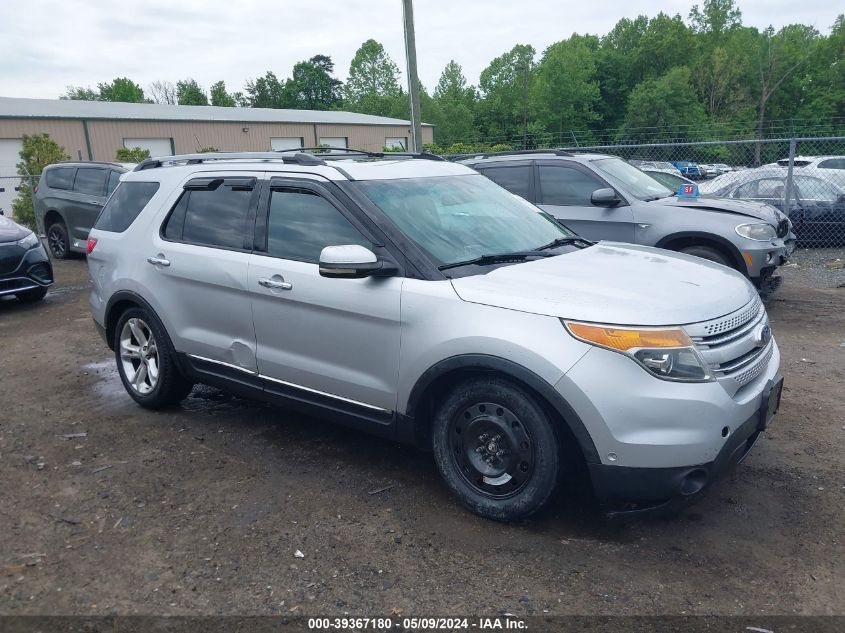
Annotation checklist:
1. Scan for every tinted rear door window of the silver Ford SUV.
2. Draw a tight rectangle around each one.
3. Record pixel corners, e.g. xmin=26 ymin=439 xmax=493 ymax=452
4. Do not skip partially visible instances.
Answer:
xmin=164 ymin=178 xmax=255 ymax=249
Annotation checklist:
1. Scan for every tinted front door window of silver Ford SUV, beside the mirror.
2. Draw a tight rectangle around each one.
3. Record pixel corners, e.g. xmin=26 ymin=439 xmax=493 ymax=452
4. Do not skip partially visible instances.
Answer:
xmin=267 ymin=189 xmax=372 ymax=264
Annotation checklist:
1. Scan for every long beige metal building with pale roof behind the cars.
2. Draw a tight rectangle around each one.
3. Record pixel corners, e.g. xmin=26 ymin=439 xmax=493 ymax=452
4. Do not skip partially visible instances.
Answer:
xmin=0 ymin=97 xmax=433 ymax=168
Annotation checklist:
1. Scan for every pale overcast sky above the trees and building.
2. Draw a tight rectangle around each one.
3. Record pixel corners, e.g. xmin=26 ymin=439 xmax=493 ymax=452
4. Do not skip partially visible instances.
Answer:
xmin=0 ymin=0 xmax=842 ymax=98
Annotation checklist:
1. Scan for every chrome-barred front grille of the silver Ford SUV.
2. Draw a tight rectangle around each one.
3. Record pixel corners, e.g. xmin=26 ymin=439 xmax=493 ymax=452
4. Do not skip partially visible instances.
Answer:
xmin=685 ymin=296 xmax=774 ymax=394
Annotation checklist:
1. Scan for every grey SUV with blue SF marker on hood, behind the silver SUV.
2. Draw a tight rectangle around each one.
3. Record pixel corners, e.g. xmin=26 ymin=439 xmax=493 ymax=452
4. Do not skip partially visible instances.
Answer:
xmin=461 ymin=150 xmax=795 ymax=294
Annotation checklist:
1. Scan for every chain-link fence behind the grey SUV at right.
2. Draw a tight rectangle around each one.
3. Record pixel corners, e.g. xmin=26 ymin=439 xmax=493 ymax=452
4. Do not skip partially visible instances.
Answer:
xmin=562 ymin=136 xmax=845 ymax=248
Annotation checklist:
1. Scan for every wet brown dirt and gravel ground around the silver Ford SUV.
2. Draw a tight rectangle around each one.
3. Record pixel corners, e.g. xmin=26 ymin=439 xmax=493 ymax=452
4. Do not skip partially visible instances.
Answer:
xmin=0 ymin=260 xmax=845 ymax=616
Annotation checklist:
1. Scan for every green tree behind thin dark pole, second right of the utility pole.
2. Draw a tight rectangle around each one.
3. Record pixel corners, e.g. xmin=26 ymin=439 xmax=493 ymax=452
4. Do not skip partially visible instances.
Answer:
xmin=478 ymin=44 xmax=536 ymax=142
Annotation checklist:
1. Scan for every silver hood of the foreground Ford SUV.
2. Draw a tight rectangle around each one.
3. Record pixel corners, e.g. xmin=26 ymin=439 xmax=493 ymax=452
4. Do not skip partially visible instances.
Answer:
xmin=452 ymin=242 xmax=756 ymax=325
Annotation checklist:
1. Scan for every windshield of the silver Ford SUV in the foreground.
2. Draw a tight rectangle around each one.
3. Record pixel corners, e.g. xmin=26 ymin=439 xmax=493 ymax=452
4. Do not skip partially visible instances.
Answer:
xmin=355 ymin=175 xmax=574 ymax=265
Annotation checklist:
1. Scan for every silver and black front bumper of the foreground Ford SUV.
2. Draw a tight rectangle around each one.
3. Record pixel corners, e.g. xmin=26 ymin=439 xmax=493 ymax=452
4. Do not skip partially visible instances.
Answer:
xmin=555 ymin=341 xmax=780 ymax=515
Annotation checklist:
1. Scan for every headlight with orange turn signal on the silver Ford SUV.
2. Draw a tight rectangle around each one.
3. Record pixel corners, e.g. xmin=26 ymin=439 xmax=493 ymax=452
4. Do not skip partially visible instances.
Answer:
xmin=563 ymin=321 xmax=714 ymax=382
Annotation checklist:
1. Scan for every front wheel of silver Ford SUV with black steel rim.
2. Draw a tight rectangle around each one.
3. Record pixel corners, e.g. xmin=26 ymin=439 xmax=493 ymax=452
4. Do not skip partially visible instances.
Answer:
xmin=432 ymin=378 xmax=561 ymax=521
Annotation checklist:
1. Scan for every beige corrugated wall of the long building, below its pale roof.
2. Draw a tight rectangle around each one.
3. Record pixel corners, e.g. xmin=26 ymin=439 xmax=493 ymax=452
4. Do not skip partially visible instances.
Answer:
xmin=0 ymin=119 xmax=433 ymax=160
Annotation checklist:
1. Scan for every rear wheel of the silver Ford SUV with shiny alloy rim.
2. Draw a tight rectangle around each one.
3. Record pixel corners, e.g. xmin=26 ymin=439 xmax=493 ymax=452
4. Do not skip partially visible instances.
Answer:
xmin=114 ymin=308 xmax=192 ymax=409
